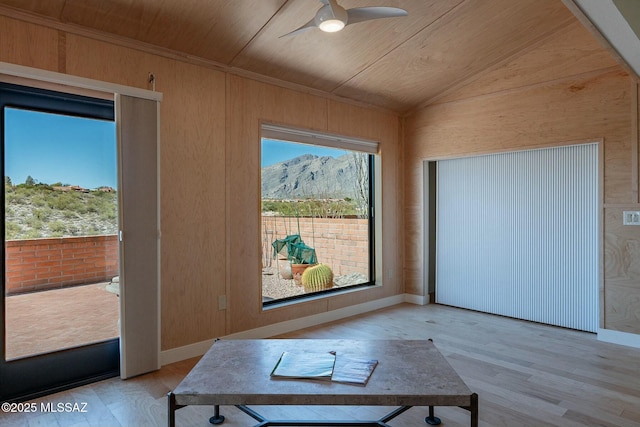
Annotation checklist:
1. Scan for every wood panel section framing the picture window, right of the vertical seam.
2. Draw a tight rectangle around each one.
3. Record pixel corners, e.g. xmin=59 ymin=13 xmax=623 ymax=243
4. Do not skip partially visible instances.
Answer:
xmin=226 ymin=75 xmax=402 ymax=333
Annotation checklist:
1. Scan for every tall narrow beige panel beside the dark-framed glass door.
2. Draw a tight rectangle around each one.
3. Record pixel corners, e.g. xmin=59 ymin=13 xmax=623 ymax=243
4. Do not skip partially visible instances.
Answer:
xmin=116 ymin=95 xmax=160 ymax=379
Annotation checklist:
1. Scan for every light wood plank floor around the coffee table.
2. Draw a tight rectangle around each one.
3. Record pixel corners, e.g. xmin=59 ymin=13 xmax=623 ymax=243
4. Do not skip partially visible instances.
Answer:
xmin=0 ymin=304 xmax=640 ymax=427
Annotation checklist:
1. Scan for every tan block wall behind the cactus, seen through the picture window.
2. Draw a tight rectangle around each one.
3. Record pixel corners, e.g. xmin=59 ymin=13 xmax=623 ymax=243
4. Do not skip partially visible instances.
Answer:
xmin=262 ymin=216 xmax=369 ymax=276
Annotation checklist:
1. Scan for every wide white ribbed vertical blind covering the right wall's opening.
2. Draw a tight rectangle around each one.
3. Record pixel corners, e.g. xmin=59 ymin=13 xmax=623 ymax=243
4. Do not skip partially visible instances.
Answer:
xmin=436 ymin=144 xmax=598 ymax=332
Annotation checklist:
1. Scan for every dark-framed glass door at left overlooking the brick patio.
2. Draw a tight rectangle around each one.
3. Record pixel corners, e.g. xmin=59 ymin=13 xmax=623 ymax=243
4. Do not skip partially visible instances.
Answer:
xmin=0 ymin=84 xmax=120 ymax=401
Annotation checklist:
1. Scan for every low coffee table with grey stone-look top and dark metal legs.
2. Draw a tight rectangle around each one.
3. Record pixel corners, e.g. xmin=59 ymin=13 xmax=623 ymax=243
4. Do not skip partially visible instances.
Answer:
xmin=168 ymin=339 xmax=478 ymax=427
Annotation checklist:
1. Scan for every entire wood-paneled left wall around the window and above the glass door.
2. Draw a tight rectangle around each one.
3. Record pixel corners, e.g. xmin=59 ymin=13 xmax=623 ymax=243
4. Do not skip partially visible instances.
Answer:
xmin=0 ymin=16 xmax=403 ymax=350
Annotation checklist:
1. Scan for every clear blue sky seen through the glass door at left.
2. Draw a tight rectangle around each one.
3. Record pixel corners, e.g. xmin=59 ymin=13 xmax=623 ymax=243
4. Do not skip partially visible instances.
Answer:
xmin=4 ymin=108 xmax=117 ymax=188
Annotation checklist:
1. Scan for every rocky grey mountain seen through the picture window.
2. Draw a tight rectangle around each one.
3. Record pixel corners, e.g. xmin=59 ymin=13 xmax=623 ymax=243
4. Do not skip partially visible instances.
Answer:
xmin=262 ymin=154 xmax=357 ymax=199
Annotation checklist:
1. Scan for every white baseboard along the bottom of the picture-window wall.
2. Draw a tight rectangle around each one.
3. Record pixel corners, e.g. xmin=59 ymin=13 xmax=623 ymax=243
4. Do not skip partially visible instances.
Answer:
xmin=160 ymin=294 xmax=422 ymax=366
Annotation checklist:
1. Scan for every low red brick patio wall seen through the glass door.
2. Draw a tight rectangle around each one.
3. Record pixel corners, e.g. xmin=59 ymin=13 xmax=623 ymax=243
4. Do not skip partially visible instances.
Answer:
xmin=5 ymin=235 xmax=118 ymax=295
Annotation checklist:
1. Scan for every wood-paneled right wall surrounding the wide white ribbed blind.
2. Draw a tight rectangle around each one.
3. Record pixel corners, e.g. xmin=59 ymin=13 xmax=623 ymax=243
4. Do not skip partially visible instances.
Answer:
xmin=404 ymin=21 xmax=640 ymax=334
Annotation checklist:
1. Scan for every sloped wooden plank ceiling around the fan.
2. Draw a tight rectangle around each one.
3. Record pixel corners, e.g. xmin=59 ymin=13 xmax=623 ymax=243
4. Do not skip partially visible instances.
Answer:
xmin=0 ymin=0 xmax=575 ymax=114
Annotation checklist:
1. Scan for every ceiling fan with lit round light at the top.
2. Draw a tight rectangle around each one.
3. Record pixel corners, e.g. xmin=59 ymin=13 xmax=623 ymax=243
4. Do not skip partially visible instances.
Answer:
xmin=280 ymin=0 xmax=408 ymax=37
